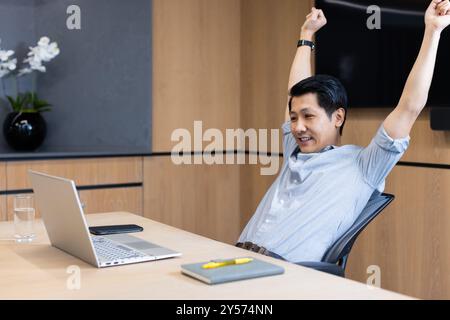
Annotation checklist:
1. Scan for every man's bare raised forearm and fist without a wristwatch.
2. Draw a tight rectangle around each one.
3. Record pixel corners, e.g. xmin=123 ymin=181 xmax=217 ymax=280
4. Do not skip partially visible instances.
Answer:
xmin=383 ymin=0 xmax=450 ymax=139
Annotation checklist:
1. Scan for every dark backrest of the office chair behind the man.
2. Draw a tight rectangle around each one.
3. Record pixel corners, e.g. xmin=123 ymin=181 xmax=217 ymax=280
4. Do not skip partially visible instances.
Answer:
xmin=322 ymin=192 xmax=394 ymax=270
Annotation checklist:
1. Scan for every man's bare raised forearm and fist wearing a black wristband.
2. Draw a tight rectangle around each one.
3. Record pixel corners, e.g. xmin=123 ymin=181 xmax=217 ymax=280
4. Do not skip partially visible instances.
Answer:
xmin=285 ymin=7 xmax=327 ymax=121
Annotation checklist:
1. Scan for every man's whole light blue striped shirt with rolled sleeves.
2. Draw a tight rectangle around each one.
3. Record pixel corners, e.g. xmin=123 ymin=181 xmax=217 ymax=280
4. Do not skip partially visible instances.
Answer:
xmin=239 ymin=121 xmax=410 ymax=262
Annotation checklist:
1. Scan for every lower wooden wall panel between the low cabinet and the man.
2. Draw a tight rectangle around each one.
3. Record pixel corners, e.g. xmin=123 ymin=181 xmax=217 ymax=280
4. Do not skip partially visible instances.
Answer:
xmin=144 ymin=157 xmax=240 ymax=244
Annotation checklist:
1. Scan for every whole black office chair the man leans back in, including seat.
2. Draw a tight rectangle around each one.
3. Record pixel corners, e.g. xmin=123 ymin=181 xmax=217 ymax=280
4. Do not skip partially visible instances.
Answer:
xmin=296 ymin=192 xmax=394 ymax=277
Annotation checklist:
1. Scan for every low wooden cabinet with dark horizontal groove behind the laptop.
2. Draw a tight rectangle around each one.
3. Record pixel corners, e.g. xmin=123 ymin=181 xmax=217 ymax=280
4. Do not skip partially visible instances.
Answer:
xmin=0 ymin=157 xmax=143 ymax=220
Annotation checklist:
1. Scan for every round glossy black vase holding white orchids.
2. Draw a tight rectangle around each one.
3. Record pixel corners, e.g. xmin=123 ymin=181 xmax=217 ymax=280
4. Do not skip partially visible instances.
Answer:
xmin=3 ymin=112 xmax=47 ymax=151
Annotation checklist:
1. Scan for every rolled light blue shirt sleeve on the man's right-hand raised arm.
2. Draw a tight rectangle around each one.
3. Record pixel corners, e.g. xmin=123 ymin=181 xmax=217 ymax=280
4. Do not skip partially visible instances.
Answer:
xmin=358 ymin=125 xmax=410 ymax=192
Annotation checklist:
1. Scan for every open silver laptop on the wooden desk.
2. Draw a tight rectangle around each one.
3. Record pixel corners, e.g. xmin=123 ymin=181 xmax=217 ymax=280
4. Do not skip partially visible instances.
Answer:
xmin=28 ymin=170 xmax=181 ymax=268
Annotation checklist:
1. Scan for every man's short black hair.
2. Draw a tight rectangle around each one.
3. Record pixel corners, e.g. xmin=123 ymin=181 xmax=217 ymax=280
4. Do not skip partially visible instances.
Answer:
xmin=289 ymin=74 xmax=347 ymax=135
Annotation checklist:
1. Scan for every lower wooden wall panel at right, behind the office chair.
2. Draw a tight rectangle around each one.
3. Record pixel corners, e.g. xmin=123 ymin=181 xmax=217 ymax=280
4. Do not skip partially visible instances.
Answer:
xmin=347 ymin=166 xmax=450 ymax=299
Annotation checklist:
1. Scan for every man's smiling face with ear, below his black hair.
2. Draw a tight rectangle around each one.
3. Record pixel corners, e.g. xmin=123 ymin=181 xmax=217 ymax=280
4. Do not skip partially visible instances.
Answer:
xmin=290 ymin=93 xmax=345 ymax=153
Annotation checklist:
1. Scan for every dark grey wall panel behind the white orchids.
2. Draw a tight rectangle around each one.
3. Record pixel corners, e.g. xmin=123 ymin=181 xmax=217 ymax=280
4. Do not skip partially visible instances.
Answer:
xmin=0 ymin=0 xmax=151 ymax=150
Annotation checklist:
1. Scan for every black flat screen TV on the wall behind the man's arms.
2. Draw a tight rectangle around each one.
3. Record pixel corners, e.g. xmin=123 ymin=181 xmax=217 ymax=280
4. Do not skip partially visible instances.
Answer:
xmin=316 ymin=0 xmax=450 ymax=109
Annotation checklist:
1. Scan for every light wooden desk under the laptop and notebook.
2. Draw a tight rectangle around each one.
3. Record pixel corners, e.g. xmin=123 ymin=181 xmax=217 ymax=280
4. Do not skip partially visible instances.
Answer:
xmin=0 ymin=212 xmax=414 ymax=299
